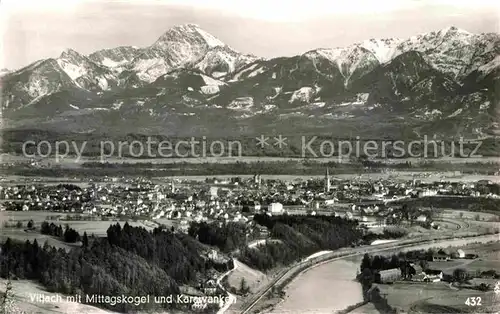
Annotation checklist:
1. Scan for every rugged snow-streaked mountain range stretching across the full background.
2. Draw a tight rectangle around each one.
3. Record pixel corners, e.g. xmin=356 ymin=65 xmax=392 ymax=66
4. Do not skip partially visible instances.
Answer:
xmin=0 ymin=24 xmax=500 ymax=138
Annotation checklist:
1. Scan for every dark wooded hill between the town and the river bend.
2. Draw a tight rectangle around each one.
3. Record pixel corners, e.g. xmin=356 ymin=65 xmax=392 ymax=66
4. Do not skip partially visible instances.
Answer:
xmin=188 ymin=214 xmax=376 ymax=271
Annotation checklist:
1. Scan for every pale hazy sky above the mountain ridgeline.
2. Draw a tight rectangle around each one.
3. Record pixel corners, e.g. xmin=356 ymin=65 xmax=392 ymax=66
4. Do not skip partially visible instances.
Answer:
xmin=0 ymin=0 xmax=500 ymax=69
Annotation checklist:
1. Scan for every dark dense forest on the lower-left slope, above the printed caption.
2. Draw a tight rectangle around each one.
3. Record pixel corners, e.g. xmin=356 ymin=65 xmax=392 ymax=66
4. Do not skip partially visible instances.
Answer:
xmin=0 ymin=224 xmax=233 ymax=313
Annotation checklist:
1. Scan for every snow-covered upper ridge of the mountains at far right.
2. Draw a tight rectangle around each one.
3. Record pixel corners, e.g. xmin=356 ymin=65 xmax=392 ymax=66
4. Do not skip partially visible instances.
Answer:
xmin=305 ymin=26 xmax=492 ymax=78
